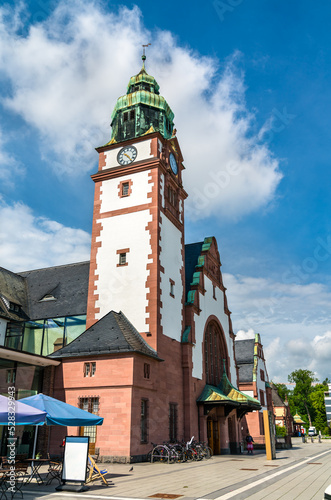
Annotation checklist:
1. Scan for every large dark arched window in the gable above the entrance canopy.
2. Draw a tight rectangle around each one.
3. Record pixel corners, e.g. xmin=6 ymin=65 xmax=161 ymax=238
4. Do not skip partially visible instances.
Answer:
xmin=204 ymin=321 xmax=228 ymax=386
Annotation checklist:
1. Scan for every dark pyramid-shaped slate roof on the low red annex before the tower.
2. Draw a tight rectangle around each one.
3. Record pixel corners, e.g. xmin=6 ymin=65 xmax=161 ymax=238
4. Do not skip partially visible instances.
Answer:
xmin=50 ymin=311 xmax=160 ymax=360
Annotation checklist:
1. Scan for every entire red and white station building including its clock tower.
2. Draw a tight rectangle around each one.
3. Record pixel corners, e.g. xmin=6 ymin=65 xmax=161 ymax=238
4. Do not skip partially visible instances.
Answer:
xmin=0 ymin=56 xmax=261 ymax=462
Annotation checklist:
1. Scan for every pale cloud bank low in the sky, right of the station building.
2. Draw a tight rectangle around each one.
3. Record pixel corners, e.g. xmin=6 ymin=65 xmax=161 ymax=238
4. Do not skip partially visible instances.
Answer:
xmin=227 ymin=274 xmax=331 ymax=382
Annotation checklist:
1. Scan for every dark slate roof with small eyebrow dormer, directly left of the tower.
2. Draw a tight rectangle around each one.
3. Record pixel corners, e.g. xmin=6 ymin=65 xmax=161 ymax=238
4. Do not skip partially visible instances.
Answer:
xmin=17 ymin=262 xmax=90 ymax=320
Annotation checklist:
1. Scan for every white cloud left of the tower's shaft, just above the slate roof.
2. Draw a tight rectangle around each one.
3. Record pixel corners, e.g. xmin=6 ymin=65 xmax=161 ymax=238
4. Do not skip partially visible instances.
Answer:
xmin=0 ymin=203 xmax=91 ymax=272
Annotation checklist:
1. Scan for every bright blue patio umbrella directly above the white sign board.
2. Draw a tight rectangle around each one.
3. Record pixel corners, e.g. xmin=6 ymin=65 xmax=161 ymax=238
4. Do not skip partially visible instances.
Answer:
xmin=20 ymin=394 xmax=103 ymax=427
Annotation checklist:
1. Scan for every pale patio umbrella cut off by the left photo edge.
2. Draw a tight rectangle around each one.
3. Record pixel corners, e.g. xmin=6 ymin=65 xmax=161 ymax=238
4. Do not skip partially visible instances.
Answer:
xmin=0 ymin=395 xmax=46 ymax=425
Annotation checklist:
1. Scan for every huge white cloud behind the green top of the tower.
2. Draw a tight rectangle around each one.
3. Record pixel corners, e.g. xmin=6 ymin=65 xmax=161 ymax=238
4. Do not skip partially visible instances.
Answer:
xmin=0 ymin=1 xmax=281 ymax=218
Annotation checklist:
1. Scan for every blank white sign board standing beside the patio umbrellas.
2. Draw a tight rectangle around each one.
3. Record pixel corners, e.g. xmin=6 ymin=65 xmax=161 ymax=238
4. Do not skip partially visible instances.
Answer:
xmin=62 ymin=436 xmax=89 ymax=483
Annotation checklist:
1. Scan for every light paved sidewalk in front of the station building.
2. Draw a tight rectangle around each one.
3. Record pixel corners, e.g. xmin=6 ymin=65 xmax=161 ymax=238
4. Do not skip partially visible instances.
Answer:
xmin=19 ymin=438 xmax=331 ymax=500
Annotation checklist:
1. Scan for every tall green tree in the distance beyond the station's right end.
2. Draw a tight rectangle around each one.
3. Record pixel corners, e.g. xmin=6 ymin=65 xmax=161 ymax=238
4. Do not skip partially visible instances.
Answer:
xmin=288 ymin=369 xmax=317 ymax=426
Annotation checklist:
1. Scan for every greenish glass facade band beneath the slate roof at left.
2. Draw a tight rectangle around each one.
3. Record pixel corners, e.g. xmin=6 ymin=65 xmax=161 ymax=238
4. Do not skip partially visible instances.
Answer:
xmin=5 ymin=315 xmax=86 ymax=356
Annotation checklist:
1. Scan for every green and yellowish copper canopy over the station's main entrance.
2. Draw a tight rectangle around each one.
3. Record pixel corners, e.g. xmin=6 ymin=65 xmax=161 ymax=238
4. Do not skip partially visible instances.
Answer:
xmin=197 ymin=369 xmax=262 ymax=418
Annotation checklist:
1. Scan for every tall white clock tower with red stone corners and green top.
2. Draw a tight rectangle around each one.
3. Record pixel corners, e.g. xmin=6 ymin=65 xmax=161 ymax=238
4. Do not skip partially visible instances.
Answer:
xmin=87 ymin=56 xmax=187 ymax=351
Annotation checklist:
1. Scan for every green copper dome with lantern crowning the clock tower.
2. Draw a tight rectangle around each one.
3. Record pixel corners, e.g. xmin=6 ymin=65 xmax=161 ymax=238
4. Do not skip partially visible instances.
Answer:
xmin=110 ymin=59 xmax=174 ymax=144
